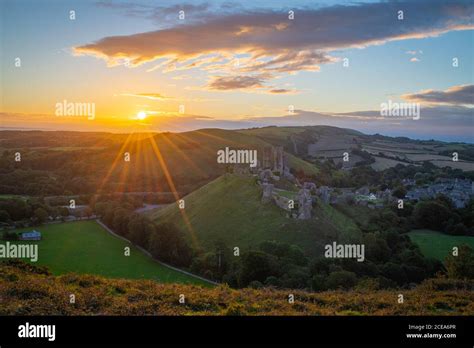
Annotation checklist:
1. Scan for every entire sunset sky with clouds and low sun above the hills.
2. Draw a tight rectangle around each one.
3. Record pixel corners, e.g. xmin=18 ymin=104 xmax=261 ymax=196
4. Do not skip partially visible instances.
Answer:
xmin=0 ymin=0 xmax=474 ymax=142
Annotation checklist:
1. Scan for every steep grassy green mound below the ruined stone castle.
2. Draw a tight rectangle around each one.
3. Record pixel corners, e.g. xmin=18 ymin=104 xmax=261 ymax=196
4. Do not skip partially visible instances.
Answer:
xmin=148 ymin=174 xmax=360 ymax=255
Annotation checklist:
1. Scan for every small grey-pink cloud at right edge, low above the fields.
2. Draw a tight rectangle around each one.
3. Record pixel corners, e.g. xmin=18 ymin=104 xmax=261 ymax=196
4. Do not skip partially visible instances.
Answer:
xmin=402 ymin=85 xmax=474 ymax=105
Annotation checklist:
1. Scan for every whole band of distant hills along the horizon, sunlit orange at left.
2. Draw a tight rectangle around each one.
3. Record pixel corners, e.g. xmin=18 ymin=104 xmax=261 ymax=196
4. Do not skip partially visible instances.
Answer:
xmin=0 ymin=126 xmax=474 ymax=196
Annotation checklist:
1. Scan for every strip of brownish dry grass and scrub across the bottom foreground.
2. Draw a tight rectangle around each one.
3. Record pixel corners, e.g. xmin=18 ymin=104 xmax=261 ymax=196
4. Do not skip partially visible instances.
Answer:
xmin=0 ymin=262 xmax=474 ymax=315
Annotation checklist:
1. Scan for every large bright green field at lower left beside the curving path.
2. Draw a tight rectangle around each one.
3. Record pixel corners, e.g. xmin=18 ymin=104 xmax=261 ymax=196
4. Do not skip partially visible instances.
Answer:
xmin=5 ymin=221 xmax=209 ymax=285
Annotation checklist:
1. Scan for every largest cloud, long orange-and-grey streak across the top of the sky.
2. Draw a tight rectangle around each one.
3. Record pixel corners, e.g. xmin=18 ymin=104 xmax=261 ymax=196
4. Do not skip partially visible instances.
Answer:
xmin=74 ymin=0 xmax=474 ymax=89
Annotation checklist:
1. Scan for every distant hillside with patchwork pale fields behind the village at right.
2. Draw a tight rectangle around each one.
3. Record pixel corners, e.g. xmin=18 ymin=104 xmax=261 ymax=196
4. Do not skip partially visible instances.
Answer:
xmin=243 ymin=126 xmax=474 ymax=172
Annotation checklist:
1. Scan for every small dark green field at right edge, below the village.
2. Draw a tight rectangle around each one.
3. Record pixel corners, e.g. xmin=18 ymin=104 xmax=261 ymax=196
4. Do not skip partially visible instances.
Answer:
xmin=408 ymin=230 xmax=474 ymax=261
